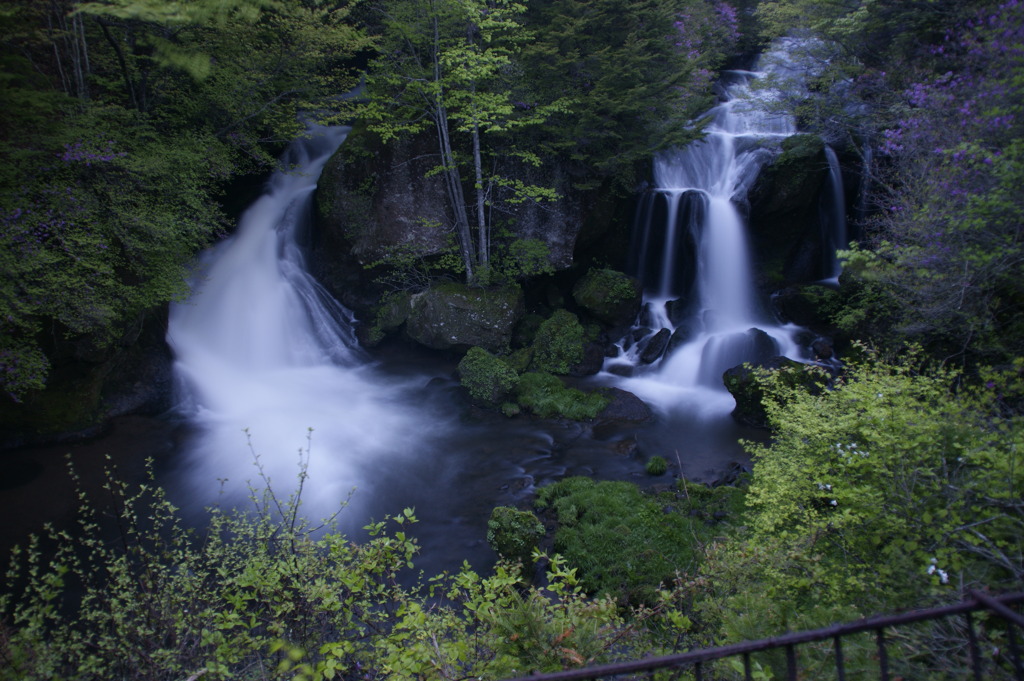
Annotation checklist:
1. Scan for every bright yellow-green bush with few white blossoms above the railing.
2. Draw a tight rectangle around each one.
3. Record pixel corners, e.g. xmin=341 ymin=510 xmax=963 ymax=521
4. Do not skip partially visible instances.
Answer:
xmin=707 ymin=353 xmax=1024 ymax=640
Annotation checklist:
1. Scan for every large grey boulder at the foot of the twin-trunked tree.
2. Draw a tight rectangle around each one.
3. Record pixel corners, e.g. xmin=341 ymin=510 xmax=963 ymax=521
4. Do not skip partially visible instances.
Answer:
xmin=406 ymin=283 xmax=526 ymax=353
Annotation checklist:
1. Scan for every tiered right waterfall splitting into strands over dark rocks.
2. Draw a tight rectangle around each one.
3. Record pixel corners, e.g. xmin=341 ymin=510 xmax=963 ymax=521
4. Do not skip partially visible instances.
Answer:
xmin=605 ymin=41 xmax=819 ymax=412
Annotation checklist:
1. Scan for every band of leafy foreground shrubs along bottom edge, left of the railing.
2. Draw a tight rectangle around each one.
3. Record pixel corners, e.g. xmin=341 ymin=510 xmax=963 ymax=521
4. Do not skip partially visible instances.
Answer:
xmin=0 ymin=458 xmax=682 ymax=681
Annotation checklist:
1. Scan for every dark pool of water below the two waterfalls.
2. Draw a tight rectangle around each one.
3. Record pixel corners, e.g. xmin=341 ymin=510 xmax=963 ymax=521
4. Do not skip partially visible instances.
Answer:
xmin=0 ymin=343 xmax=760 ymax=574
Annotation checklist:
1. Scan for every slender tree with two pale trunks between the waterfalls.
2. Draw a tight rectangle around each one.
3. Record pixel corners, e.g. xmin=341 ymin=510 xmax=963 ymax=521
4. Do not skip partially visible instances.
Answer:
xmin=362 ymin=0 xmax=563 ymax=282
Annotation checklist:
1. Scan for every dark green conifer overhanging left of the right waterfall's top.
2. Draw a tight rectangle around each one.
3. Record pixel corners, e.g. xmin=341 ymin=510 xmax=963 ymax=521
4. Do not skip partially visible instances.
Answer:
xmin=520 ymin=0 xmax=738 ymax=191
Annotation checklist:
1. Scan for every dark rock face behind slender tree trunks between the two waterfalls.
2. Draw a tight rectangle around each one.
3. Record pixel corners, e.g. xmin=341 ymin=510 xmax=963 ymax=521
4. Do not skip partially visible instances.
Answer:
xmin=314 ymin=127 xmax=585 ymax=296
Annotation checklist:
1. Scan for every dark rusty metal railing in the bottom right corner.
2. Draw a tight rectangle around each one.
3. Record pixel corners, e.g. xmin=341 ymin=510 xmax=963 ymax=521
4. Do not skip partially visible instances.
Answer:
xmin=501 ymin=591 xmax=1024 ymax=681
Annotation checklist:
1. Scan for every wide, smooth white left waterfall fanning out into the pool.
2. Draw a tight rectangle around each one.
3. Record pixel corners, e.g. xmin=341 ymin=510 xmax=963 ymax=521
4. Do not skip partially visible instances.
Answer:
xmin=167 ymin=126 xmax=431 ymax=515
